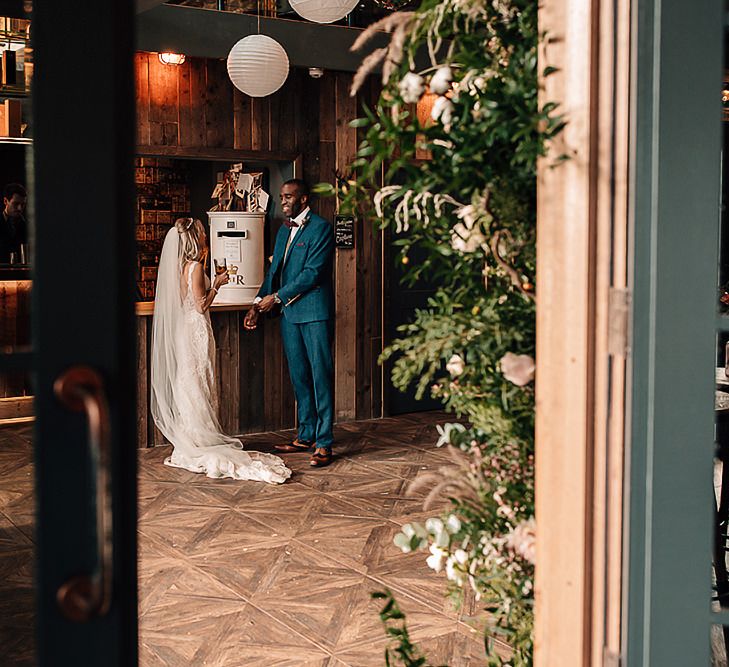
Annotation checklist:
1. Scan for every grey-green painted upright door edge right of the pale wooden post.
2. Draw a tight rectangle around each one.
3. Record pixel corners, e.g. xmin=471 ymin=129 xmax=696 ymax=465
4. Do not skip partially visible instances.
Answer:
xmin=624 ymin=0 xmax=725 ymax=667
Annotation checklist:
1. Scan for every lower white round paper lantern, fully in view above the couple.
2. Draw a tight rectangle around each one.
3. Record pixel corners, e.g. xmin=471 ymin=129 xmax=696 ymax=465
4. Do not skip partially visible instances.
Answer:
xmin=228 ymin=35 xmax=289 ymax=97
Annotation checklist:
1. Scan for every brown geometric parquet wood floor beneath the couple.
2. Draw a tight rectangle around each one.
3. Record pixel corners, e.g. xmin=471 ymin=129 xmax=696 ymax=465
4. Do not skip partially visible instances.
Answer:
xmin=0 ymin=413 xmax=506 ymax=667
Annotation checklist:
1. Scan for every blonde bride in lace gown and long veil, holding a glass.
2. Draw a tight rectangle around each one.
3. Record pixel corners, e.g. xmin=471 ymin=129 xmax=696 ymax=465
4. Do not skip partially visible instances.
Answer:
xmin=151 ymin=218 xmax=291 ymax=484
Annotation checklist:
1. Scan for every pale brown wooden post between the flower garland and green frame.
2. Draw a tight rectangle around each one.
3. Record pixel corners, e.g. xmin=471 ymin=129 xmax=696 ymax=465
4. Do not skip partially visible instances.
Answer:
xmin=535 ymin=0 xmax=630 ymax=667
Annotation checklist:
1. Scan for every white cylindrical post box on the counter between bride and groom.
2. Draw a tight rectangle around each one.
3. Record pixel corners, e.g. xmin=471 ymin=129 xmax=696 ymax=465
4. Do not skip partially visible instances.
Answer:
xmin=208 ymin=211 xmax=266 ymax=306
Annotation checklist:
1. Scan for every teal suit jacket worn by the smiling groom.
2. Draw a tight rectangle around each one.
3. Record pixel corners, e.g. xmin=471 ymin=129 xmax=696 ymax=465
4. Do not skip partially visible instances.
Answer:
xmin=258 ymin=213 xmax=334 ymax=324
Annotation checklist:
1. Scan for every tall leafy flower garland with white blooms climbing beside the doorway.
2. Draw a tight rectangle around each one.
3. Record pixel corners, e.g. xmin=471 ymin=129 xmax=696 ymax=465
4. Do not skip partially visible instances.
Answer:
xmin=316 ymin=0 xmax=562 ymax=666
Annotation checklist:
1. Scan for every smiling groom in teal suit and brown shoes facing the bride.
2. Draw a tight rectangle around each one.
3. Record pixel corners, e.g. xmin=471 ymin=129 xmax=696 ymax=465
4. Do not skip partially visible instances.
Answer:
xmin=243 ymin=178 xmax=334 ymax=467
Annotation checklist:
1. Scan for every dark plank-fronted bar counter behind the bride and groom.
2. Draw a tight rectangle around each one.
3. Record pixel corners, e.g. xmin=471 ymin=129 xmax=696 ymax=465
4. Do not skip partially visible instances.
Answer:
xmin=137 ymin=302 xmax=296 ymax=447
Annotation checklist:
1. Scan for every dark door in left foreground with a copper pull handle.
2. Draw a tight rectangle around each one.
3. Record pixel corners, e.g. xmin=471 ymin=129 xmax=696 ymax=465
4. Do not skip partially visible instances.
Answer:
xmin=25 ymin=0 xmax=137 ymax=667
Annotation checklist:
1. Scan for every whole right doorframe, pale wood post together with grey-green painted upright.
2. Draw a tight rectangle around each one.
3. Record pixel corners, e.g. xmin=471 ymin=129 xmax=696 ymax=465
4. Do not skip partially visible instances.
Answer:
xmin=535 ymin=0 xmax=725 ymax=667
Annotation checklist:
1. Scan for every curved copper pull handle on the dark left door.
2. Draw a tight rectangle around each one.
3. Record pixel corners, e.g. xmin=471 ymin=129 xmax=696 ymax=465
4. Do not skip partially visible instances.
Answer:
xmin=53 ymin=366 xmax=114 ymax=622
